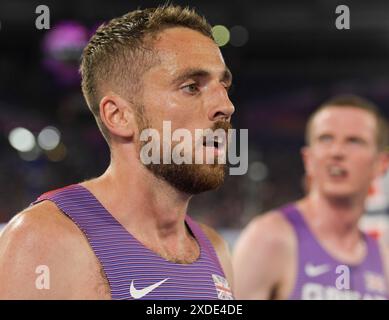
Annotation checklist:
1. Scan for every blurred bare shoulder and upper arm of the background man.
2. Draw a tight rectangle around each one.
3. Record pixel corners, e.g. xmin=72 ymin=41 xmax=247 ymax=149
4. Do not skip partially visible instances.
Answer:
xmin=233 ymin=212 xmax=294 ymax=300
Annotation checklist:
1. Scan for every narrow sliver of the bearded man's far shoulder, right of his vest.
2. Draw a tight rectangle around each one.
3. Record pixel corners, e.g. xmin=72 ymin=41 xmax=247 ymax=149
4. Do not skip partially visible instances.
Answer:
xmin=199 ymin=223 xmax=233 ymax=286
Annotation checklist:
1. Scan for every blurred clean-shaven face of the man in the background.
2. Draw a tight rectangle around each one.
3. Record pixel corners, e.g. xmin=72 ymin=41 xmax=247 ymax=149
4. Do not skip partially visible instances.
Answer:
xmin=303 ymin=106 xmax=386 ymax=198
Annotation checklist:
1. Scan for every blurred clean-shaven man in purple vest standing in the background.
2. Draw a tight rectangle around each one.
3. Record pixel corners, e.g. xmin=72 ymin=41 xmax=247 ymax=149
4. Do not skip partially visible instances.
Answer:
xmin=233 ymin=96 xmax=389 ymax=300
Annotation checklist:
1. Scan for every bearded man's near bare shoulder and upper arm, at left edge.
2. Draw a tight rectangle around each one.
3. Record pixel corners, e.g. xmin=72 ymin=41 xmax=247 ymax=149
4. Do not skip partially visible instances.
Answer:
xmin=0 ymin=201 xmax=104 ymax=299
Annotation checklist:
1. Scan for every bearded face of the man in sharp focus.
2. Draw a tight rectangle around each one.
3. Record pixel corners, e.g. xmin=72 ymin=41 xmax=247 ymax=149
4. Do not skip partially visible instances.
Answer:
xmin=135 ymin=28 xmax=234 ymax=194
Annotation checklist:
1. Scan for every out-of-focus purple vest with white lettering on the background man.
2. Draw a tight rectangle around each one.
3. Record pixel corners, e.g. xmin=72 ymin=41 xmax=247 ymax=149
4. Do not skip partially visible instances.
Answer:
xmin=281 ymin=205 xmax=388 ymax=300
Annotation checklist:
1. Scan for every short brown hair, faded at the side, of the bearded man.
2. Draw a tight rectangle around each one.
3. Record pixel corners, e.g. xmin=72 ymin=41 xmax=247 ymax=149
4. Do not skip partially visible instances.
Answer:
xmin=80 ymin=5 xmax=213 ymax=144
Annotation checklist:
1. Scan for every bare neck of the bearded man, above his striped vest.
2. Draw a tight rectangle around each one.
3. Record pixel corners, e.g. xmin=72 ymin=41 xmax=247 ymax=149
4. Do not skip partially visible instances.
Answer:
xmin=84 ymin=154 xmax=190 ymax=240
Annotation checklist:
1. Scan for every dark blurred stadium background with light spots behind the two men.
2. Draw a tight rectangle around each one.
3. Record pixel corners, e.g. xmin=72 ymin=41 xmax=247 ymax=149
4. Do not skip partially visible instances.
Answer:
xmin=0 ymin=0 xmax=389 ymax=238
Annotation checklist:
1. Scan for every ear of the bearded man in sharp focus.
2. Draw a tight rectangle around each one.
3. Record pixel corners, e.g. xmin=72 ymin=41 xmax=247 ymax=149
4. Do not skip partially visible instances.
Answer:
xmin=99 ymin=94 xmax=136 ymax=138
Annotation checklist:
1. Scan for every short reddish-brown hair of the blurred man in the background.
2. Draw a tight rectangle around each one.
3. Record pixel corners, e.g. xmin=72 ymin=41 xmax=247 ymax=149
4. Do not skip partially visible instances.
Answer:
xmin=305 ymin=95 xmax=389 ymax=151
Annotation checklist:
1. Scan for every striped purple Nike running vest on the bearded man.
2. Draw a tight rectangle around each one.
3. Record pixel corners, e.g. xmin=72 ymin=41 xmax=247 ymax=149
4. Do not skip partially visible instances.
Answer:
xmin=33 ymin=184 xmax=233 ymax=300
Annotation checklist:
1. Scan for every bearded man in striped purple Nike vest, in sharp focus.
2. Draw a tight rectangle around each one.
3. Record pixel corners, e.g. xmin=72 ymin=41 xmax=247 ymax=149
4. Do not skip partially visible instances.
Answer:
xmin=0 ymin=6 xmax=234 ymax=299
